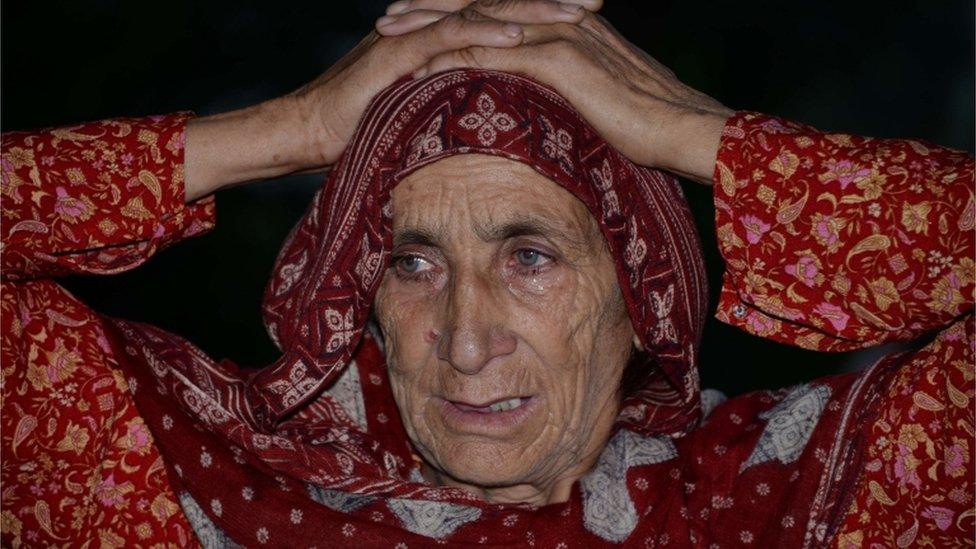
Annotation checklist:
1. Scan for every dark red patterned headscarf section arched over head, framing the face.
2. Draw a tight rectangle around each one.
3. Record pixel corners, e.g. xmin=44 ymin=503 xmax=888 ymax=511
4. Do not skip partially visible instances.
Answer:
xmin=255 ymin=70 xmax=707 ymax=434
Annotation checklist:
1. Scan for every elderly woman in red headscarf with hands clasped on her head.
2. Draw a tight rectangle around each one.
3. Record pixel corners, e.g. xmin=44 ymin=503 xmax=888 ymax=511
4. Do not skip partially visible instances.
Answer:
xmin=2 ymin=0 xmax=976 ymax=547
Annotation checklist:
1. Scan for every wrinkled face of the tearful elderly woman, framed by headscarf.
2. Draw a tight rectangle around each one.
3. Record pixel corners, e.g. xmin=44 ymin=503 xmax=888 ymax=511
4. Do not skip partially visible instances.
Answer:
xmin=376 ymin=154 xmax=634 ymax=503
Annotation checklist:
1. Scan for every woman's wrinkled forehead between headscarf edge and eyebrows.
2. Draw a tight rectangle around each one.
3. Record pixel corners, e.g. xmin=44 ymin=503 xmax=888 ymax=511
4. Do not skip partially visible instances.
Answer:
xmin=391 ymin=150 xmax=606 ymax=253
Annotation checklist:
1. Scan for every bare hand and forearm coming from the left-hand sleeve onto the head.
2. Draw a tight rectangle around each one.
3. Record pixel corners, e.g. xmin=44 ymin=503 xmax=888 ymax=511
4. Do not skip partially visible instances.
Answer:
xmin=185 ymin=0 xmax=599 ymax=201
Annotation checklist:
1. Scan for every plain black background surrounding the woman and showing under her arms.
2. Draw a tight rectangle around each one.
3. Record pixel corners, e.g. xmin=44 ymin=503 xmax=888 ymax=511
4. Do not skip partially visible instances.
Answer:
xmin=0 ymin=0 xmax=974 ymax=394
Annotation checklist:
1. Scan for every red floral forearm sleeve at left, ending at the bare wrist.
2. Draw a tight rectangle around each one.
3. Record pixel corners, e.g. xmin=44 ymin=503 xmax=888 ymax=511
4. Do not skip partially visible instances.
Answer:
xmin=0 ymin=114 xmax=214 ymax=280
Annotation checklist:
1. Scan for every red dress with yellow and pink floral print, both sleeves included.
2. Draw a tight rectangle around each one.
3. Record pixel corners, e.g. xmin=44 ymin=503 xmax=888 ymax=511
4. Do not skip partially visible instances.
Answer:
xmin=0 ymin=113 xmax=976 ymax=547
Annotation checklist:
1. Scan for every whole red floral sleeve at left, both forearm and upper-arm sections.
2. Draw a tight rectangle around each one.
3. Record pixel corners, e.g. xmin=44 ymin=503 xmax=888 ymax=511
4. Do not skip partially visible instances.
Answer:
xmin=0 ymin=115 xmax=213 ymax=547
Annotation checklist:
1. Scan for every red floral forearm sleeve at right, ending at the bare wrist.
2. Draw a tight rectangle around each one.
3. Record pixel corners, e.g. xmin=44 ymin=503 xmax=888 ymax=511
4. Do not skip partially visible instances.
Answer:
xmin=714 ymin=112 xmax=976 ymax=351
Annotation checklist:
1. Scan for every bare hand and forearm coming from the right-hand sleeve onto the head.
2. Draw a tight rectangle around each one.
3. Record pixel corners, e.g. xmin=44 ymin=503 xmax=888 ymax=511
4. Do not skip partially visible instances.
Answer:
xmin=378 ymin=0 xmax=733 ymax=184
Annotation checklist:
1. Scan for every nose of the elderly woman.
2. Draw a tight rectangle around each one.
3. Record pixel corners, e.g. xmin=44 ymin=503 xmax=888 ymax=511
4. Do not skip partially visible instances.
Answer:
xmin=436 ymin=273 xmax=517 ymax=375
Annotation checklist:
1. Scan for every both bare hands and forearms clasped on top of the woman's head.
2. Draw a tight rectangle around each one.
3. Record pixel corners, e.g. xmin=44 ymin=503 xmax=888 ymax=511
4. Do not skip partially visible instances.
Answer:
xmin=185 ymin=0 xmax=732 ymax=200
